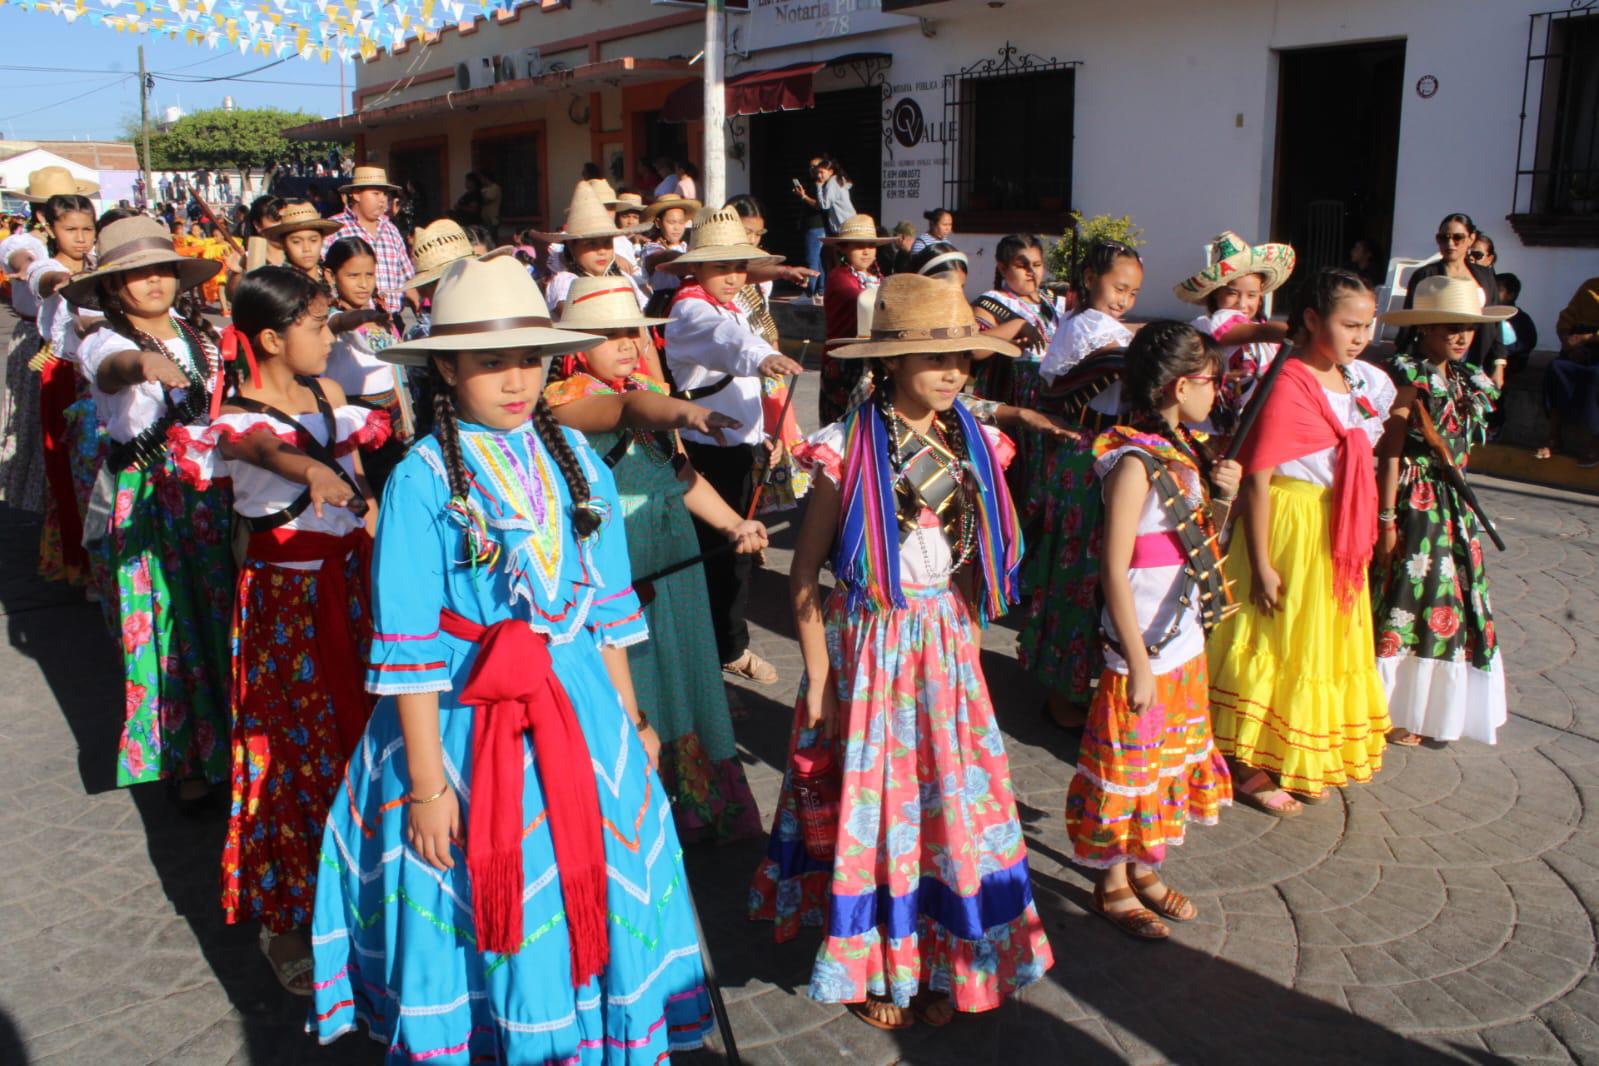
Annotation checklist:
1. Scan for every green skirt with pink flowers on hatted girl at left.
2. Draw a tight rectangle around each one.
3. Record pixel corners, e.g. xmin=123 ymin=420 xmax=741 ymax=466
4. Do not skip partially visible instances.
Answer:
xmin=109 ymin=452 xmax=233 ymax=785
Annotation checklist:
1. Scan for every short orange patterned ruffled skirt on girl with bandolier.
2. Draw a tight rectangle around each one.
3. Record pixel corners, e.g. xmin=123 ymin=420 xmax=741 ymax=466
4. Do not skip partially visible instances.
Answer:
xmin=1067 ymin=655 xmax=1233 ymax=869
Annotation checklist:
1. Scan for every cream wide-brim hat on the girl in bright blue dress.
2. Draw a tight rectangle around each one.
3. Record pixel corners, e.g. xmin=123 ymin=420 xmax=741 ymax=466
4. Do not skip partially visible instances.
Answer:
xmin=377 ymin=256 xmax=604 ymax=366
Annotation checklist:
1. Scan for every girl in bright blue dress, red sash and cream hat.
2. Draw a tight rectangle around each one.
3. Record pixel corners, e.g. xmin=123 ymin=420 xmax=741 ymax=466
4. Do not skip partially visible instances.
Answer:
xmin=309 ymin=257 xmax=712 ymax=1066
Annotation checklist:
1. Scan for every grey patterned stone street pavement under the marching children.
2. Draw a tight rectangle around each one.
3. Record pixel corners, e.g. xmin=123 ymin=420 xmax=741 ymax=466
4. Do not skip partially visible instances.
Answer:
xmin=0 ymin=362 xmax=1599 ymax=1066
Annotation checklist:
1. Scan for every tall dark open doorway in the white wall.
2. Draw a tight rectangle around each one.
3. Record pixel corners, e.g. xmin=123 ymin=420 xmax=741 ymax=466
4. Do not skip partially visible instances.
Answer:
xmin=1271 ymin=40 xmax=1404 ymax=295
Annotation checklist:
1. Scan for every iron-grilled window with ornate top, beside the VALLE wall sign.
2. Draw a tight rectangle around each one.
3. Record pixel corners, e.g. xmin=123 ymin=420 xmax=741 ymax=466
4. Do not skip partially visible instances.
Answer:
xmin=943 ymin=43 xmax=1078 ymax=232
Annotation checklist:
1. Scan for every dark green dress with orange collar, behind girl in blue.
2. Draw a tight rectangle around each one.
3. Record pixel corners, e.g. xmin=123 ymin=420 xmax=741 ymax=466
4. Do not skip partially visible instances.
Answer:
xmin=545 ymin=371 xmax=761 ymax=842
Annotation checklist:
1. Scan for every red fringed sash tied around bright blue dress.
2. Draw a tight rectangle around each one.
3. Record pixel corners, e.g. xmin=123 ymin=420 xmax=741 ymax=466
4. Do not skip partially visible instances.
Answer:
xmin=438 ymin=611 xmax=611 ymax=988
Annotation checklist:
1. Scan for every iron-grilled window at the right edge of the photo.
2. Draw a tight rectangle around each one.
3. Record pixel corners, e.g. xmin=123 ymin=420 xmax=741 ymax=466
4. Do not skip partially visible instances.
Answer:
xmin=1509 ymin=0 xmax=1599 ymax=245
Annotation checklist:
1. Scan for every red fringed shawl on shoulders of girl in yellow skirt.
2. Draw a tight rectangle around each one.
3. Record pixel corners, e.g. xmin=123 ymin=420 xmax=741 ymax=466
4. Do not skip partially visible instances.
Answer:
xmin=1238 ymin=358 xmax=1377 ymax=614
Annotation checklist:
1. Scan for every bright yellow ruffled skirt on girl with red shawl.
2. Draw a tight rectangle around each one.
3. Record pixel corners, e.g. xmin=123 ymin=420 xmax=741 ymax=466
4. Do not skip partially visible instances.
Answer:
xmin=1206 ymin=478 xmax=1388 ymax=794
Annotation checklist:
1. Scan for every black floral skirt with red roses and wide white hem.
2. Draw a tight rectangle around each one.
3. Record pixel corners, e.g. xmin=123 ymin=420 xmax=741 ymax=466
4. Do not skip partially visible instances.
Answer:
xmin=1372 ymin=457 xmax=1509 ymax=745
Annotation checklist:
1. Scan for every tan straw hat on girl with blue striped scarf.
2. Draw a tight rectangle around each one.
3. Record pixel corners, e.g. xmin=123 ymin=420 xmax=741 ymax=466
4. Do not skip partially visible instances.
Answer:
xmin=828 ymin=273 xmax=1022 ymax=360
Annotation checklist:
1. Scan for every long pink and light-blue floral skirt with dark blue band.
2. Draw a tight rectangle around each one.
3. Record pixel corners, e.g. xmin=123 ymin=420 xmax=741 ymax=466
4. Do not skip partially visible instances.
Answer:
xmin=750 ymin=587 xmax=1054 ymax=1012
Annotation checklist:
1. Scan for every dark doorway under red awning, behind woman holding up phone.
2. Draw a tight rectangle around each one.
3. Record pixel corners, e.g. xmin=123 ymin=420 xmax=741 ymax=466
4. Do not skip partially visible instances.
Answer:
xmin=748 ymin=88 xmax=892 ymax=265
